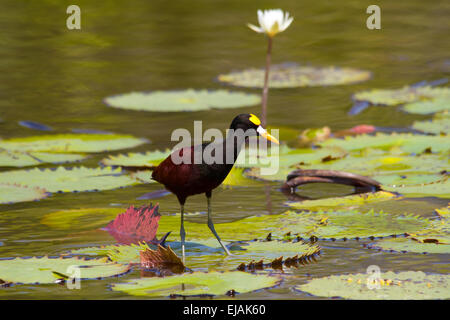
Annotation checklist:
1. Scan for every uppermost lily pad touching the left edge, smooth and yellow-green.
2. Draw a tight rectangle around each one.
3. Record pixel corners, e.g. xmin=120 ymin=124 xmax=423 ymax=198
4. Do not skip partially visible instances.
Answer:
xmin=0 ymin=133 xmax=148 ymax=153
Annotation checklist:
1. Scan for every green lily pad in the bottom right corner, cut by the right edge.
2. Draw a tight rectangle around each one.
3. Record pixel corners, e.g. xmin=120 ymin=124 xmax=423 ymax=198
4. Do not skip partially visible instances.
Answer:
xmin=295 ymin=271 xmax=450 ymax=300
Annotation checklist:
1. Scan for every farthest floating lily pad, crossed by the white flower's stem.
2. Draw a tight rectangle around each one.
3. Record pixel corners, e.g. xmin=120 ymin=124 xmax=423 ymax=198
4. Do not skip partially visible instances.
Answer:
xmin=218 ymin=63 xmax=371 ymax=88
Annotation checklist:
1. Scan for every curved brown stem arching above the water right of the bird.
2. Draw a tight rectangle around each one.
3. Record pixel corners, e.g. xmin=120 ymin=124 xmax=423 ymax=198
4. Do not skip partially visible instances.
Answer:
xmin=281 ymin=170 xmax=381 ymax=193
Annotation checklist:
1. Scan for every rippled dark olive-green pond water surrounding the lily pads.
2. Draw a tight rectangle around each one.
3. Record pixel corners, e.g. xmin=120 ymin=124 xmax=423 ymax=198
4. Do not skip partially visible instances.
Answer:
xmin=0 ymin=0 xmax=450 ymax=299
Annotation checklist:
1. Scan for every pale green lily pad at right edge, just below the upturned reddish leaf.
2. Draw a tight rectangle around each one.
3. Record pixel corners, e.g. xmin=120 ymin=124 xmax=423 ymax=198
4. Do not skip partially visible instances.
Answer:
xmin=321 ymin=133 xmax=450 ymax=153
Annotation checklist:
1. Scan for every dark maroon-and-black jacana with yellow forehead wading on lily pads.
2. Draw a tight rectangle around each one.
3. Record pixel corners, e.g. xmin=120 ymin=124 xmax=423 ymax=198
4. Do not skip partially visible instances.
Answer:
xmin=152 ymin=114 xmax=279 ymax=260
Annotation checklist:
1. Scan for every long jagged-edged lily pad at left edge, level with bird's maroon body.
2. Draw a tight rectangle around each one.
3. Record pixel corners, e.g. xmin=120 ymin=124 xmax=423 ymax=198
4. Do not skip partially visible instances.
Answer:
xmin=0 ymin=167 xmax=137 ymax=192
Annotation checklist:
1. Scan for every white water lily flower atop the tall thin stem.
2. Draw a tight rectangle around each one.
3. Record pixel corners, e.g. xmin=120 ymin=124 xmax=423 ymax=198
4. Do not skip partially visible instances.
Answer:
xmin=247 ymin=9 xmax=294 ymax=37
